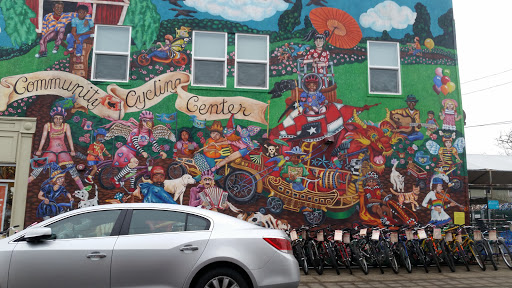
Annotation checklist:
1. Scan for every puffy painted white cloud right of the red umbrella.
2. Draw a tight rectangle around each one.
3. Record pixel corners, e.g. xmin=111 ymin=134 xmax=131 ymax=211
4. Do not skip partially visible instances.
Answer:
xmin=360 ymin=0 xmax=416 ymax=32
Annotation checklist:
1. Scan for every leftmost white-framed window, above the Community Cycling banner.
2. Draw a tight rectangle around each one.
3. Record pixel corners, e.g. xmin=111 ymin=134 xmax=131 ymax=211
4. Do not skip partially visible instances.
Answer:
xmin=91 ymin=25 xmax=132 ymax=82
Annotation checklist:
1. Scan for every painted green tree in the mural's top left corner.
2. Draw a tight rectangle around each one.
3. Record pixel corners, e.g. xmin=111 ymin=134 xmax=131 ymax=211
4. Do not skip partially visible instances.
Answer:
xmin=0 ymin=1 xmax=37 ymax=48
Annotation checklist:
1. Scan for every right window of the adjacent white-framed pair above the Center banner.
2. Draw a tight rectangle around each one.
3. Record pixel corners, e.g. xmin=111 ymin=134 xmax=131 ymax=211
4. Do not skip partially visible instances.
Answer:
xmin=235 ymin=33 xmax=269 ymax=89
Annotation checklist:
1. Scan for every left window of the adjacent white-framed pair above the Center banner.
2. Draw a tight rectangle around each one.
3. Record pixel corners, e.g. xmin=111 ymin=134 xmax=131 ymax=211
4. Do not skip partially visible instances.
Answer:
xmin=192 ymin=31 xmax=228 ymax=87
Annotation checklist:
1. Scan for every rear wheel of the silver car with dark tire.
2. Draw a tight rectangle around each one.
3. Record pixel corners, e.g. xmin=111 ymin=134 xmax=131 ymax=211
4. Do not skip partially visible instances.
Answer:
xmin=194 ymin=268 xmax=249 ymax=288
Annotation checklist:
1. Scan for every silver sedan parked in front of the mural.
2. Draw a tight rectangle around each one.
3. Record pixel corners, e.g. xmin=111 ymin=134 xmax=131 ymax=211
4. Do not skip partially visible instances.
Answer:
xmin=0 ymin=204 xmax=300 ymax=288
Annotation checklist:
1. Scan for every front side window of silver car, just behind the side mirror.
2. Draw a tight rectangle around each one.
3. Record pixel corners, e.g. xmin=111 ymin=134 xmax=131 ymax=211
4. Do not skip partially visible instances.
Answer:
xmin=46 ymin=210 xmax=121 ymax=239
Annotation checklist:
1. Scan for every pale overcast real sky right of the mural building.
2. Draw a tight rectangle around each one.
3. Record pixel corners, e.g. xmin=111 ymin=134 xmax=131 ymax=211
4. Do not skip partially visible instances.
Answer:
xmin=452 ymin=0 xmax=512 ymax=155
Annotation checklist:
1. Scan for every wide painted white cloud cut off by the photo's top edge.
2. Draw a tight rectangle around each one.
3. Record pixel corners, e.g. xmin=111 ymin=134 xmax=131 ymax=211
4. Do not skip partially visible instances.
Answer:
xmin=184 ymin=0 xmax=288 ymax=21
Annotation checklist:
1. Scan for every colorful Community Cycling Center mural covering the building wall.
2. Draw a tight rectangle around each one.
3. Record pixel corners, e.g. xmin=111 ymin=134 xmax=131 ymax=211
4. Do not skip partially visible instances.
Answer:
xmin=0 ymin=0 xmax=468 ymax=229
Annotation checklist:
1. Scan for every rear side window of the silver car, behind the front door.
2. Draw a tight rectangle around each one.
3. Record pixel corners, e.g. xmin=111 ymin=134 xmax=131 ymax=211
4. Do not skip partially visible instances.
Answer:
xmin=128 ymin=210 xmax=210 ymax=234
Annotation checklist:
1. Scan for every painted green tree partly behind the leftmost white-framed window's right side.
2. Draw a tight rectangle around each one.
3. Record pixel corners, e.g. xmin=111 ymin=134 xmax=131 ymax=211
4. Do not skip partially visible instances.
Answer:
xmin=124 ymin=0 xmax=160 ymax=49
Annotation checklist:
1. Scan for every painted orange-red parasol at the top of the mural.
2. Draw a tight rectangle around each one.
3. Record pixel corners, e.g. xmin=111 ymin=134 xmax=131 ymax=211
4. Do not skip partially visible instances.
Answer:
xmin=309 ymin=7 xmax=363 ymax=48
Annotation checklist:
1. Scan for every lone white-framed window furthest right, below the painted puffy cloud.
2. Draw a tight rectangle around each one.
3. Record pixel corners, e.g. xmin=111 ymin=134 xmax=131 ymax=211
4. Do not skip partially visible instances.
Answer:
xmin=367 ymin=41 xmax=402 ymax=95
